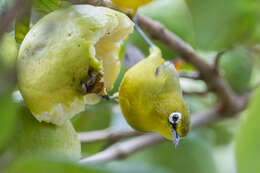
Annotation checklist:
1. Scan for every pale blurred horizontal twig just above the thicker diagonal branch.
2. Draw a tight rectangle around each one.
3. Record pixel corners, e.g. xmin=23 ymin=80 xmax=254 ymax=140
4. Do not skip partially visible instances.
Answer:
xmin=78 ymin=129 xmax=143 ymax=143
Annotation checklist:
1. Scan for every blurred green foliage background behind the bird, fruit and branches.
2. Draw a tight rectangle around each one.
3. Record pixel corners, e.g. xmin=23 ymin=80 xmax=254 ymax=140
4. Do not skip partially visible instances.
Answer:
xmin=0 ymin=0 xmax=260 ymax=173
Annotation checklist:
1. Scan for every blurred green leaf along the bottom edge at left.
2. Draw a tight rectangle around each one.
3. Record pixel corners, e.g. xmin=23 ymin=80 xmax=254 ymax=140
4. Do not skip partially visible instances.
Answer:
xmin=4 ymin=154 xmax=108 ymax=173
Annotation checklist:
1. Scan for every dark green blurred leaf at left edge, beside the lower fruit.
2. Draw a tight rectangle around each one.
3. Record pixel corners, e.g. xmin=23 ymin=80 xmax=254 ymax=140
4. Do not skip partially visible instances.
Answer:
xmin=0 ymin=92 xmax=17 ymax=150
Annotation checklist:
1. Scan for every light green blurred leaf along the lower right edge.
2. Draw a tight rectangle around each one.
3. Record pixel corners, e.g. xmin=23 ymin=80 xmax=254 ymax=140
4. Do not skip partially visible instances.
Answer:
xmin=236 ymin=88 xmax=260 ymax=173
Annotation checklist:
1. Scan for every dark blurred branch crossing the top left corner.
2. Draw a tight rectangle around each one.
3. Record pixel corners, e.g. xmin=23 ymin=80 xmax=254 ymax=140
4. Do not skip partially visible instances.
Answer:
xmin=0 ymin=0 xmax=31 ymax=38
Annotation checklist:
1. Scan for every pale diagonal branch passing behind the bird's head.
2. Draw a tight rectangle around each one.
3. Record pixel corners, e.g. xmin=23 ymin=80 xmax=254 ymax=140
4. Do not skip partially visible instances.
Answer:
xmin=80 ymin=106 xmax=220 ymax=164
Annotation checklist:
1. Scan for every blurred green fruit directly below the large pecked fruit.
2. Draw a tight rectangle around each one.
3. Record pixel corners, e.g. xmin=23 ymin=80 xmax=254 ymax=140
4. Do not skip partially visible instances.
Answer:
xmin=15 ymin=107 xmax=81 ymax=160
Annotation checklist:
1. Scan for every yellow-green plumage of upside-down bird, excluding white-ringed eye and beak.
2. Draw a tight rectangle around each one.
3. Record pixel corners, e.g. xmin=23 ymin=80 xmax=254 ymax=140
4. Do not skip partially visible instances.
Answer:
xmin=119 ymin=47 xmax=190 ymax=140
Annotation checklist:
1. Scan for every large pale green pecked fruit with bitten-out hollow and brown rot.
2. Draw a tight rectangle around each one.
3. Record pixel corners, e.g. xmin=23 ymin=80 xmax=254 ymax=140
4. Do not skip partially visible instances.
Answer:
xmin=17 ymin=5 xmax=134 ymax=125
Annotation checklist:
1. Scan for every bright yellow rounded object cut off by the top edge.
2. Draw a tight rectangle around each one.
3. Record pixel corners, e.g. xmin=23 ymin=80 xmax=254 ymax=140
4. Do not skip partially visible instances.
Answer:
xmin=112 ymin=0 xmax=153 ymax=10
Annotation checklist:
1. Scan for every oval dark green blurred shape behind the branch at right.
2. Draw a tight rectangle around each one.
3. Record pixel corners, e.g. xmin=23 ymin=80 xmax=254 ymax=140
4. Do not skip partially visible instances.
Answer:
xmin=220 ymin=46 xmax=253 ymax=93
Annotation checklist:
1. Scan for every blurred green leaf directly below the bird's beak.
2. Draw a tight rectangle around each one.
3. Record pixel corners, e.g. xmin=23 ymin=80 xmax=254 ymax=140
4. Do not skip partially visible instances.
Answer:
xmin=132 ymin=132 xmax=217 ymax=173
